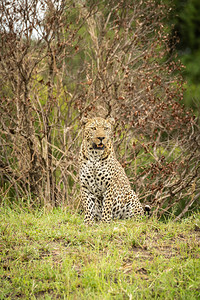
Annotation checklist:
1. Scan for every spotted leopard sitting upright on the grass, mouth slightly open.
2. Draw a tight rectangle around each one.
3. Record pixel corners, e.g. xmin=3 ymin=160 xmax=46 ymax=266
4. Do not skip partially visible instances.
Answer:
xmin=79 ymin=117 xmax=148 ymax=225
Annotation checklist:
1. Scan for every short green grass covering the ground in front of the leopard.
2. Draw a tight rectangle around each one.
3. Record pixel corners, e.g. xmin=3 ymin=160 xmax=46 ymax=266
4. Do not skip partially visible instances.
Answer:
xmin=0 ymin=209 xmax=200 ymax=300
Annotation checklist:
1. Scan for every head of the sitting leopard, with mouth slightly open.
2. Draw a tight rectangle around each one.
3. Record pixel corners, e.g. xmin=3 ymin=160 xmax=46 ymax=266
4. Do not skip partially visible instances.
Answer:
xmin=82 ymin=117 xmax=115 ymax=151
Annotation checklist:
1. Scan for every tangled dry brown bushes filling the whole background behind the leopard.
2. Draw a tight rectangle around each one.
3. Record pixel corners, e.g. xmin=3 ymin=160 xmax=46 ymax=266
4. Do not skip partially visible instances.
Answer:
xmin=0 ymin=0 xmax=200 ymax=219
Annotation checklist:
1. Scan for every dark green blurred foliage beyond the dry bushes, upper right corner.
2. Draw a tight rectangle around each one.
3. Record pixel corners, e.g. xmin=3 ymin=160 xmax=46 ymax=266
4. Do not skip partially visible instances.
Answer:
xmin=171 ymin=0 xmax=200 ymax=113
